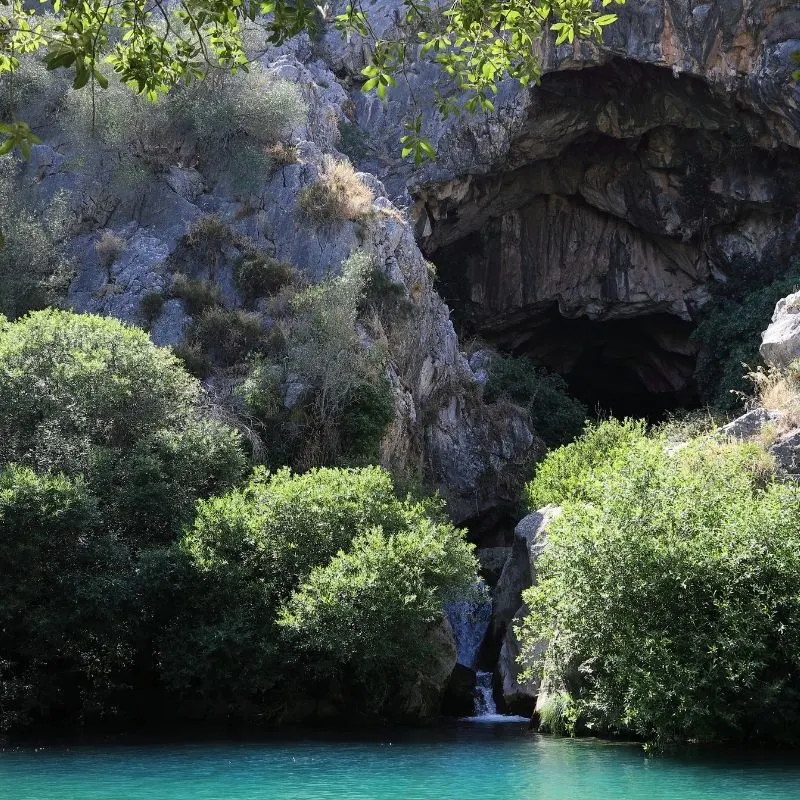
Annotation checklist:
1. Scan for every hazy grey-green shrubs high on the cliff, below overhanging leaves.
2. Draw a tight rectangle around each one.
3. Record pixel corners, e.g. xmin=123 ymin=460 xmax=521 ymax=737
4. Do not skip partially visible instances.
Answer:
xmin=59 ymin=63 xmax=306 ymax=196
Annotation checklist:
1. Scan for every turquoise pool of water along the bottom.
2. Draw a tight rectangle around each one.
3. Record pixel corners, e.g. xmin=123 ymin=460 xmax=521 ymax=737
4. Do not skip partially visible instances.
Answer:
xmin=0 ymin=724 xmax=800 ymax=800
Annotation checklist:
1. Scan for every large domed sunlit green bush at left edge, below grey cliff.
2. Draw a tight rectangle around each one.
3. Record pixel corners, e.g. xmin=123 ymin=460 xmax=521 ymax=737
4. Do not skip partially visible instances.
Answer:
xmin=0 ymin=311 xmax=244 ymax=541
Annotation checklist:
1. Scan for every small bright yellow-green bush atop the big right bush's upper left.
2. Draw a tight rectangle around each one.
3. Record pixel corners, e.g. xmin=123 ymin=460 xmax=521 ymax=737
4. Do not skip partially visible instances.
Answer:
xmin=525 ymin=419 xmax=645 ymax=510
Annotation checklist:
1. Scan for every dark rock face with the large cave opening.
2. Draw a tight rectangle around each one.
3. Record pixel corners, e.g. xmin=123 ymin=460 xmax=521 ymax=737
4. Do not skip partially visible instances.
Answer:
xmin=326 ymin=0 xmax=800 ymax=412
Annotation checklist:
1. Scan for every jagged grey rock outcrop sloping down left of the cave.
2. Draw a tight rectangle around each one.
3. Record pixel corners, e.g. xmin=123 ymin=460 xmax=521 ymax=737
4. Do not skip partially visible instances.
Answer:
xmin=14 ymin=37 xmax=542 ymax=522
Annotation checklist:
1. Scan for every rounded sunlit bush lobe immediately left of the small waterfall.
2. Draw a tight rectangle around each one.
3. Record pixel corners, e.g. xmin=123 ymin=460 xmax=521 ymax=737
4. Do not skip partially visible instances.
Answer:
xmin=280 ymin=514 xmax=475 ymax=687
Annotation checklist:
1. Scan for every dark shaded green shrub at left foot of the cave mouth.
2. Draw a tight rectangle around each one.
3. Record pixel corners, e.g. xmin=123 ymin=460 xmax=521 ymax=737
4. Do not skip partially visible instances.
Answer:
xmin=484 ymin=355 xmax=586 ymax=447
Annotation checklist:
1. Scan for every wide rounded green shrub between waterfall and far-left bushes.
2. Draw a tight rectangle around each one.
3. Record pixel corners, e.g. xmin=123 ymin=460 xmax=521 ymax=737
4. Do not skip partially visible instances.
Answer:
xmin=159 ymin=467 xmax=475 ymax=717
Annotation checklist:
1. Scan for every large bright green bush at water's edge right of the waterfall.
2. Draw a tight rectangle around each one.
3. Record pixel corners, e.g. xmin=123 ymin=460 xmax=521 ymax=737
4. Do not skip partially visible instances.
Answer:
xmin=521 ymin=422 xmax=800 ymax=746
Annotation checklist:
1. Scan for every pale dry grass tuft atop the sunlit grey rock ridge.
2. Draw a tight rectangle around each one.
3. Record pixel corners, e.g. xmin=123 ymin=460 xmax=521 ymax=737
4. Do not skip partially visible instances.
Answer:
xmin=297 ymin=156 xmax=375 ymax=223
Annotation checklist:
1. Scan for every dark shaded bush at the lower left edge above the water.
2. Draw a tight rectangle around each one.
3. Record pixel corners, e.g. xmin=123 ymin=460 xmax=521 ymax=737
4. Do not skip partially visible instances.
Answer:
xmin=0 ymin=465 xmax=128 ymax=731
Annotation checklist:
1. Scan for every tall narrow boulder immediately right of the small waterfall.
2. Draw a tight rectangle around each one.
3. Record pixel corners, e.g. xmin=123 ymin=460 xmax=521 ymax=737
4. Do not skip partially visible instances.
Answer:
xmin=488 ymin=505 xmax=561 ymax=652
